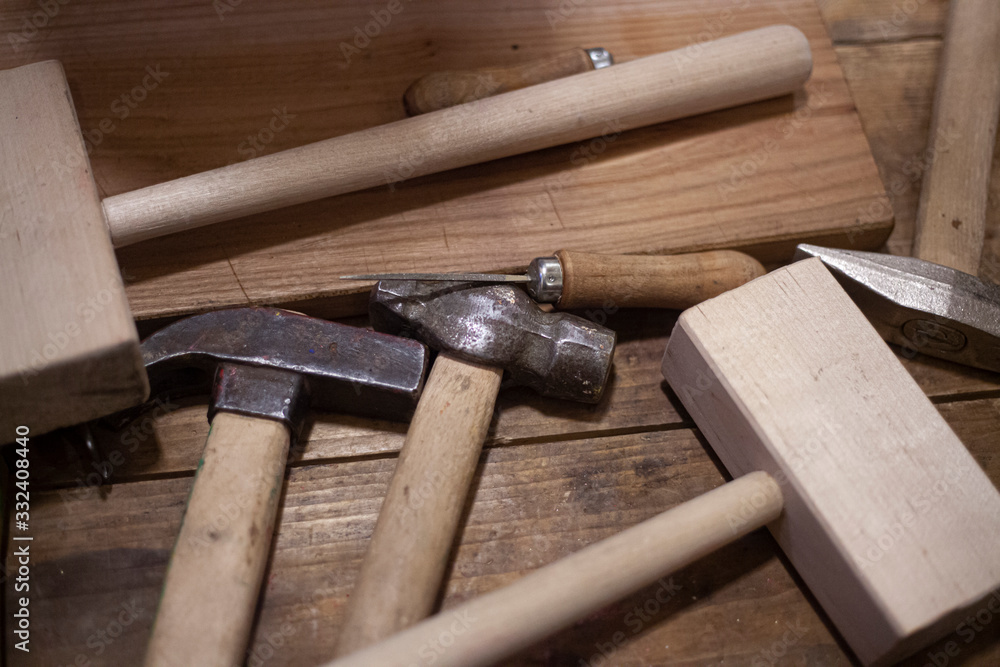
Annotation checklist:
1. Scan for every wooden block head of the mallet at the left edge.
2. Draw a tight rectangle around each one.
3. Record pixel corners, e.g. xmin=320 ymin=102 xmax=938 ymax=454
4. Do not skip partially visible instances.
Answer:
xmin=0 ymin=61 xmax=149 ymax=442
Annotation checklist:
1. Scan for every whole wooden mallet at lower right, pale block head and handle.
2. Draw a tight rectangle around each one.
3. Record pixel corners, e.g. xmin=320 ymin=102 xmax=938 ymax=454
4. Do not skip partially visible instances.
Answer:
xmin=330 ymin=259 xmax=1000 ymax=667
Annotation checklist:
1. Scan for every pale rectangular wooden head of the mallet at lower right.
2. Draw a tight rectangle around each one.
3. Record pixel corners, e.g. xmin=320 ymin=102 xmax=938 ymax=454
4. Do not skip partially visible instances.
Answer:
xmin=663 ymin=260 xmax=1000 ymax=664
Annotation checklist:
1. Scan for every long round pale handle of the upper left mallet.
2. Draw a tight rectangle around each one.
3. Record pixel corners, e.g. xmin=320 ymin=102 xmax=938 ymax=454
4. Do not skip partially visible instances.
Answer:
xmin=104 ymin=26 xmax=812 ymax=247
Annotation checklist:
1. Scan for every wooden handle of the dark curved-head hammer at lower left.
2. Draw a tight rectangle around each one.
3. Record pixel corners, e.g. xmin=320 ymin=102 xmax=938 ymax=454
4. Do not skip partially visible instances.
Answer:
xmin=145 ymin=412 xmax=289 ymax=667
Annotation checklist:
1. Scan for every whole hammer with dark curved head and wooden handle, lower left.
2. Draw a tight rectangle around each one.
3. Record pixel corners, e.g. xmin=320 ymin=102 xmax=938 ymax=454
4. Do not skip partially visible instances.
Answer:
xmin=131 ymin=308 xmax=429 ymax=666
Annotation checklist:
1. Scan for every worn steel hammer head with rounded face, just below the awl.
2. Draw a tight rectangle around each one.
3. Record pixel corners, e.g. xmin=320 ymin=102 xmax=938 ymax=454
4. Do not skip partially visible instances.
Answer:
xmin=369 ymin=280 xmax=615 ymax=403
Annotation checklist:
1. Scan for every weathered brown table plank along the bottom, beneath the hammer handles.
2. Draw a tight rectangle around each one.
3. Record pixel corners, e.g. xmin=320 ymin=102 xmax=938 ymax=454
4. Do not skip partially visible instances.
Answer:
xmin=7 ymin=398 xmax=1000 ymax=667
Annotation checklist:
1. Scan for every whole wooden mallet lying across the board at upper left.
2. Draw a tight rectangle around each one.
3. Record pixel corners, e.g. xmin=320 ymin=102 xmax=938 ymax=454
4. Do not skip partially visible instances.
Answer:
xmin=0 ymin=26 xmax=812 ymax=440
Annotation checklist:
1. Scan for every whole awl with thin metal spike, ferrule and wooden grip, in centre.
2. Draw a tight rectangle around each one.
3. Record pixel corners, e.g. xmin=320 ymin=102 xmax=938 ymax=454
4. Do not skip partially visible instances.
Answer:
xmin=341 ymin=250 xmax=764 ymax=309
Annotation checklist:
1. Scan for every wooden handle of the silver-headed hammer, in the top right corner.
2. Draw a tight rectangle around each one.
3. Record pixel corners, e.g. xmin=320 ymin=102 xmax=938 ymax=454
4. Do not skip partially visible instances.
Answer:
xmin=913 ymin=0 xmax=1000 ymax=275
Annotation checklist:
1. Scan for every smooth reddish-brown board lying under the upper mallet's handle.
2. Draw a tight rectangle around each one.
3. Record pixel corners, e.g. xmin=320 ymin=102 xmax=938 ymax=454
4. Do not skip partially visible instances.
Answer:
xmin=0 ymin=0 xmax=892 ymax=318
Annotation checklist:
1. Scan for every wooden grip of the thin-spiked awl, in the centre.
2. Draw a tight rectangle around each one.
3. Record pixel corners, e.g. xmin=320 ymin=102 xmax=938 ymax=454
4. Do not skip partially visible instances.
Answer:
xmin=556 ymin=250 xmax=765 ymax=309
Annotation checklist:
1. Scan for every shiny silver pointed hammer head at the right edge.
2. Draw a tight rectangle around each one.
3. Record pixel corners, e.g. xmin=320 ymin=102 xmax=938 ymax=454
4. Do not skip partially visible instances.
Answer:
xmin=795 ymin=244 xmax=1000 ymax=372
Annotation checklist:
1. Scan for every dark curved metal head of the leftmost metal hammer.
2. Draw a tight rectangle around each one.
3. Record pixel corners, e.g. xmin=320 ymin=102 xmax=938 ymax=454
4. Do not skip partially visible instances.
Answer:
xmin=127 ymin=308 xmax=429 ymax=434
